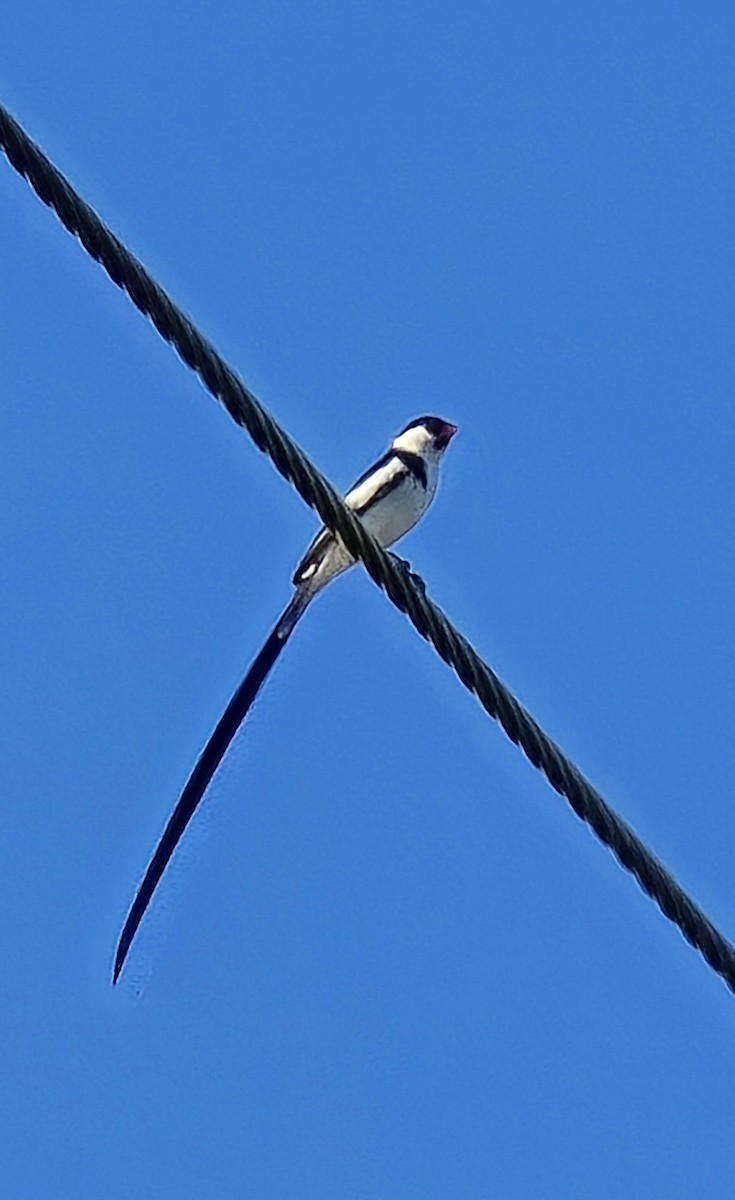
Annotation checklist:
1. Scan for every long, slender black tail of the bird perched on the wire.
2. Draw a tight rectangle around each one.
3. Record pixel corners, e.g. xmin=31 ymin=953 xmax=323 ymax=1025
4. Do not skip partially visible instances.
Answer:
xmin=113 ymin=593 xmax=307 ymax=983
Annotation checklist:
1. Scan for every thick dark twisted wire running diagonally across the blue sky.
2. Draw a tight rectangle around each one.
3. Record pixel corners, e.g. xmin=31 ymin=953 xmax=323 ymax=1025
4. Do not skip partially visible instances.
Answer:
xmin=0 ymin=104 xmax=735 ymax=992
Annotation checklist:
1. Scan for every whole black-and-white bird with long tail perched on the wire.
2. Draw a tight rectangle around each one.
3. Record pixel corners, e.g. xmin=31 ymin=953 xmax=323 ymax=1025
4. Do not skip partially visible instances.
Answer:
xmin=113 ymin=416 xmax=456 ymax=983
